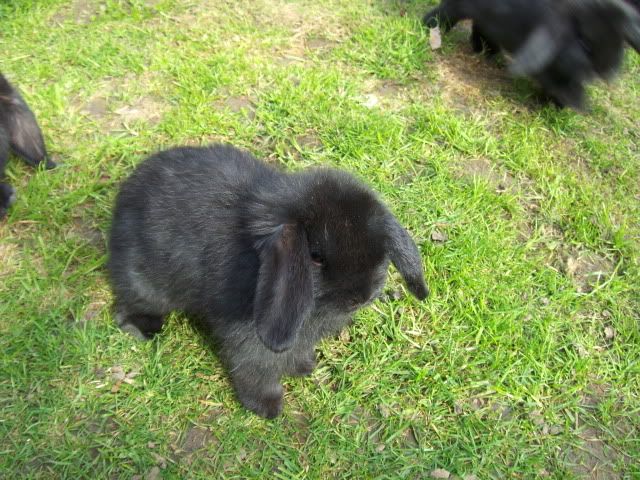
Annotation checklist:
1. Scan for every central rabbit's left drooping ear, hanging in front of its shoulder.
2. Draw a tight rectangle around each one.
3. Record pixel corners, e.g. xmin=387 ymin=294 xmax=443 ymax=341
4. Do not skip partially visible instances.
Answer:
xmin=253 ymin=225 xmax=313 ymax=352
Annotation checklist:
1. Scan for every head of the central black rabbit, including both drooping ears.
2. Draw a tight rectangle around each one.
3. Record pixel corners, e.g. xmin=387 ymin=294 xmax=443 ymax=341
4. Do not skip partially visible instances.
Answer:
xmin=252 ymin=170 xmax=428 ymax=352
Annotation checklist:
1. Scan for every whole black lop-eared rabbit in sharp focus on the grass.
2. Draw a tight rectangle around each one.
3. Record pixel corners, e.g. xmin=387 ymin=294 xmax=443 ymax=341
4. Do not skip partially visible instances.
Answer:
xmin=108 ymin=145 xmax=428 ymax=418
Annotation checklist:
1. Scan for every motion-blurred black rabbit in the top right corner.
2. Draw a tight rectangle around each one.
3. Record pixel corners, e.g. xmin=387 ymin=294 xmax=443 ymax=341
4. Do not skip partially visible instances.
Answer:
xmin=423 ymin=0 xmax=640 ymax=109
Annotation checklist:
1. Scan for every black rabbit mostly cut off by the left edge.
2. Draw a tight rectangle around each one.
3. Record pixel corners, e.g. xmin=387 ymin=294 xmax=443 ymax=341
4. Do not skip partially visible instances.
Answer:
xmin=0 ymin=73 xmax=56 ymax=219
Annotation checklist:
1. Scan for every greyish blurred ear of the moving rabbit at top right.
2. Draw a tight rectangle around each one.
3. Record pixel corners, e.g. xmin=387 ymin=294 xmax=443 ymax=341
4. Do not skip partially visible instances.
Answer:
xmin=509 ymin=25 xmax=561 ymax=76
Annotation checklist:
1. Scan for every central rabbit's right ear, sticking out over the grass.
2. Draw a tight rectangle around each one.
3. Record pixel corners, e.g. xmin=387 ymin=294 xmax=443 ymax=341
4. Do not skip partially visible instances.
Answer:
xmin=385 ymin=213 xmax=429 ymax=300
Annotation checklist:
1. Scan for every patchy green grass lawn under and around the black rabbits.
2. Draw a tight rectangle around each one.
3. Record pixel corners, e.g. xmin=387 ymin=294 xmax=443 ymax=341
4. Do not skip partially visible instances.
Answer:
xmin=0 ymin=0 xmax=640 ymax=479
